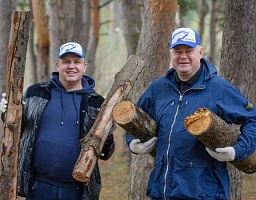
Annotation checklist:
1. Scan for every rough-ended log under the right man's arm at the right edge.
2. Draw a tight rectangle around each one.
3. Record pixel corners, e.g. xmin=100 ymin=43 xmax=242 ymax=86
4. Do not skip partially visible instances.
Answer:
xmin=184 ymin=108 xmax=256 ymax=174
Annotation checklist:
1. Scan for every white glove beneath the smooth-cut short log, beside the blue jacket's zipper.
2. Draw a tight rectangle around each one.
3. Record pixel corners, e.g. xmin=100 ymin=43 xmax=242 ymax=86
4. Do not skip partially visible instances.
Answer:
xmin=130 ymin=137 xmax=157 ymax=154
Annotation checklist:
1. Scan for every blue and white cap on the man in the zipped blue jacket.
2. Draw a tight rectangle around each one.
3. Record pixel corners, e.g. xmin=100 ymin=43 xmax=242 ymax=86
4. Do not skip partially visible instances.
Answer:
xmin=170 ymin=28 xmax=201 ymax=49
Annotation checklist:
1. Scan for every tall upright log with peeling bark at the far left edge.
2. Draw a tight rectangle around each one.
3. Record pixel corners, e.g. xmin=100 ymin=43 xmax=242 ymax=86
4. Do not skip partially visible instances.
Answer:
xmin=0 ymin=11 xmax=31 ymax=200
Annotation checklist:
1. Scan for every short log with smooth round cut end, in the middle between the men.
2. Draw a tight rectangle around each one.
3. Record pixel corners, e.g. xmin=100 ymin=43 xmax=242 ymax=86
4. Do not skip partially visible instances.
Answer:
xmin=112 ymin=101 xmax=157 ymax=157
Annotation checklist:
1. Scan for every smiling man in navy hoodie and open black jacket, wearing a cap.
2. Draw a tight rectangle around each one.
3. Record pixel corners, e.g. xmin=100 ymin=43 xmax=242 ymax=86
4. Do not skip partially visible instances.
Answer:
xmin=0 ymin=42 xmax=115 ymax=200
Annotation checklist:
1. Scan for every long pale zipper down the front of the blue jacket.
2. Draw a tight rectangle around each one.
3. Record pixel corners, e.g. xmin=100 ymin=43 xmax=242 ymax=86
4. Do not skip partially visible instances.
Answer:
xmin=164 ymin=93 xmax=184 ymax=200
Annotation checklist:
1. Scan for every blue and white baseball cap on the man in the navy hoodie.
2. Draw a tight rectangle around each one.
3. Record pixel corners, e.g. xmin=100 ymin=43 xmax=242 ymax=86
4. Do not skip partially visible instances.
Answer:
xmin=58 ymin=42 xmax=85 ymax=59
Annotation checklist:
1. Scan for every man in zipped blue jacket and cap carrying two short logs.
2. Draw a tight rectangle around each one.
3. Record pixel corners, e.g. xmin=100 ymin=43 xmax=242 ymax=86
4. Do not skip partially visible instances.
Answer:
xmin=126 ymin=28 xmax=256 ymax=200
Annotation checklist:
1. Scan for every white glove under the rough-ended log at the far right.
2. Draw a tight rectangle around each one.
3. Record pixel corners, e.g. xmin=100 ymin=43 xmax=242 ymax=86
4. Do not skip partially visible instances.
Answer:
xmin=206 ymin=147 xmax=236 ymax=162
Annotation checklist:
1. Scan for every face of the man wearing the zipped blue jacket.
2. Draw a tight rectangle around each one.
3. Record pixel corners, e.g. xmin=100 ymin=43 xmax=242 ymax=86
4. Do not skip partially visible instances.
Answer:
xmin=170 ymin=45 xmax=203 ymax=81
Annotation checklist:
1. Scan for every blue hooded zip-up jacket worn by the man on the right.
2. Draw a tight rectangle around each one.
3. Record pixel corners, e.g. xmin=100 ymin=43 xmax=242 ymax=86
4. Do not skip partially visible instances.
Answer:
xmin=126 ymin=58 xmax=256 ymax=200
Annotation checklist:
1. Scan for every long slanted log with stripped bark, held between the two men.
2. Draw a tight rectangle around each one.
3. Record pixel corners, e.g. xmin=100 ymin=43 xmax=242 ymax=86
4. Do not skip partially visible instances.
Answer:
xmin=72 ymin=55 xmax=144 ymax=182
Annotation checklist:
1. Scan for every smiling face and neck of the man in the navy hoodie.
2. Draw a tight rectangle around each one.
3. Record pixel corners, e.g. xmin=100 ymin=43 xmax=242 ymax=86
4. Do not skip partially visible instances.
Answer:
xmin=56 ymin=53 xmax=87 ymax=90
